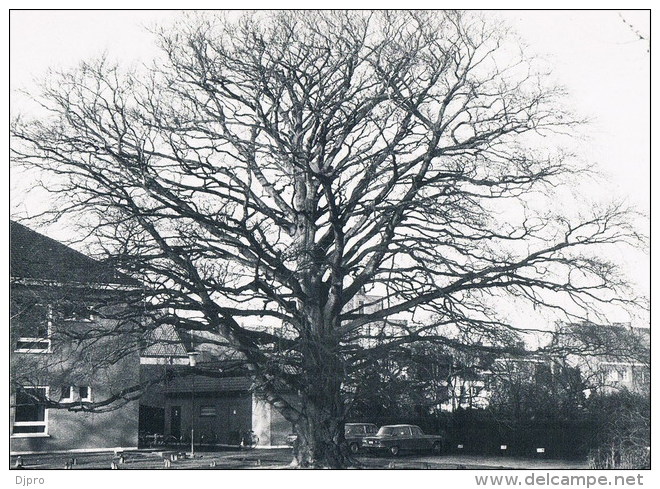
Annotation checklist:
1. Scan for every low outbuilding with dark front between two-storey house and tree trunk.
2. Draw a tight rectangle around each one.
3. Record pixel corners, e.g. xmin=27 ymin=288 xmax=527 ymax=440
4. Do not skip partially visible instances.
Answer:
xmin=139 ymin=325 xmax=293 ymax=446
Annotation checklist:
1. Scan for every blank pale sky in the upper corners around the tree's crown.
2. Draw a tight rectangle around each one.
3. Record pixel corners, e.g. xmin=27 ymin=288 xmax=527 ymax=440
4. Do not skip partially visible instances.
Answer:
xmin=10 ymin=10 xmax=650 ymax=304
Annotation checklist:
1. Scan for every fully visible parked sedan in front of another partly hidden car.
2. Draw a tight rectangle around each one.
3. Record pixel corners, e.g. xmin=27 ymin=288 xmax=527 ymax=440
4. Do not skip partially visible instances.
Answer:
xmin=362 ymin=424 xmax=445 ymax=456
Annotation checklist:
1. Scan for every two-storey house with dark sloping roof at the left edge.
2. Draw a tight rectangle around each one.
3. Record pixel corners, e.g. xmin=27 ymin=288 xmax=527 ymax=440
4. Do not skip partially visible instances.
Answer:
xmin=10 ymin=222 xmax=139 ymax=453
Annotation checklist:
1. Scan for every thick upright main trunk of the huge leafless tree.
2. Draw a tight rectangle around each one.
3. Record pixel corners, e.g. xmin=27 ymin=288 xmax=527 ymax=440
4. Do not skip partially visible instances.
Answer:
xmin=284 ymin=163 xmax=352 ymax=468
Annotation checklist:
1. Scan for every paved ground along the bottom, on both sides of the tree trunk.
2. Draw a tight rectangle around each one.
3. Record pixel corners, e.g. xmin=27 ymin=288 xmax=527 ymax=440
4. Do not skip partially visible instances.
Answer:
xmin=10 ymin=449 xmax=587 ymax=470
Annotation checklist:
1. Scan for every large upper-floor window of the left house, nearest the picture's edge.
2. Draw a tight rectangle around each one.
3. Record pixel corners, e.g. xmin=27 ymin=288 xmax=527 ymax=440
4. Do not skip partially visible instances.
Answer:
xmin=11 ymin=303 xmax=53 ymax=353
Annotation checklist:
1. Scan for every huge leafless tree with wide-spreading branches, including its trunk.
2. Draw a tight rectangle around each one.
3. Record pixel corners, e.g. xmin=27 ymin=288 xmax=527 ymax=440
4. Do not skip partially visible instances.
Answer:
xmin=11 ymin=12 xmax=638 ymax=467
